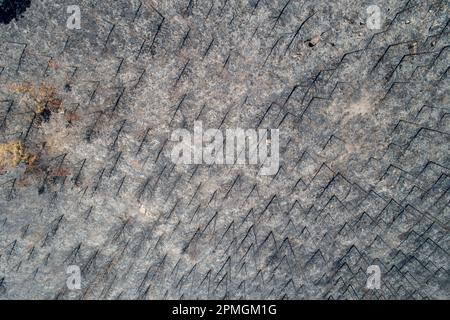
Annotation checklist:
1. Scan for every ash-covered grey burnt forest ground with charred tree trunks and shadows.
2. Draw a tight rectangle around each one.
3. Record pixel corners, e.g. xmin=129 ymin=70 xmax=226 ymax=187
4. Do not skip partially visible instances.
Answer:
xmin=0 ymin=0 xmax=450 ymax=299
